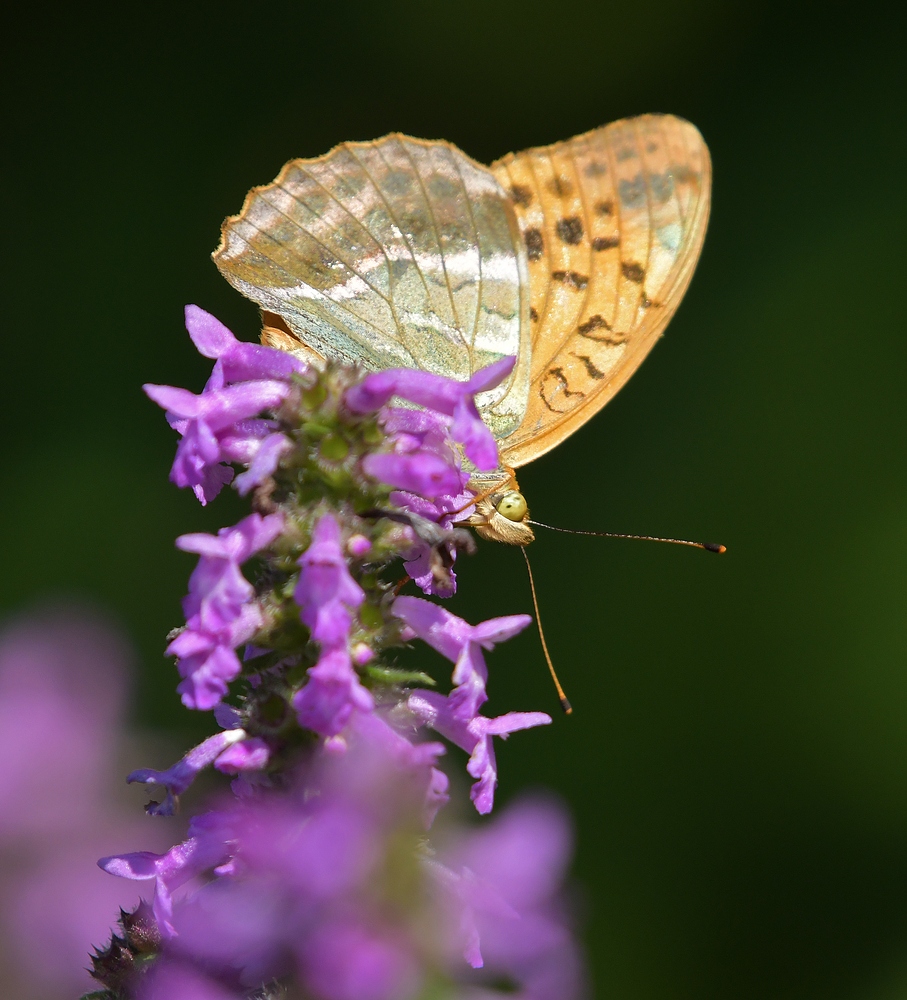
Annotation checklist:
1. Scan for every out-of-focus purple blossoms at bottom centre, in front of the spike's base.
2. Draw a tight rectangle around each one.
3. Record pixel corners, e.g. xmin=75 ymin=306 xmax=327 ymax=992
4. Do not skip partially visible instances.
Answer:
xmin=102 ymin=728 xmax=580 ymax=1000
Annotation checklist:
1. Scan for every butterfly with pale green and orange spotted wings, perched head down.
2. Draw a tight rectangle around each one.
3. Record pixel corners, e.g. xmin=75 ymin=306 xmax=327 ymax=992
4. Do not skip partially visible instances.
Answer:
xmin=213 ymin=115 xmax=711 ymax=545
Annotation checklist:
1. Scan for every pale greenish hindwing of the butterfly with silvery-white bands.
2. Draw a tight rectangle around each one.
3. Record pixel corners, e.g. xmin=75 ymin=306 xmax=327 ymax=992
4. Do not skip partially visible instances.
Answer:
xmin=214 ymin=135 xmax=531 ymax=438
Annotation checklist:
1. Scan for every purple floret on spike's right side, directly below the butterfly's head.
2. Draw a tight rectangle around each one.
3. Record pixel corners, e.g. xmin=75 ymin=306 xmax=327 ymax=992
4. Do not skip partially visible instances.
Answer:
xmin=393 ymin=597 xmax=532 ymax=722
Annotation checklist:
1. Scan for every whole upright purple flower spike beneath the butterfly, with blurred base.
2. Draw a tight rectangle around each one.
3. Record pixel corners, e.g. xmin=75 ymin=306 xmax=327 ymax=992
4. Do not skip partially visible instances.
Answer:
xmin=87 ymin=307 xmax=581 ymax=1000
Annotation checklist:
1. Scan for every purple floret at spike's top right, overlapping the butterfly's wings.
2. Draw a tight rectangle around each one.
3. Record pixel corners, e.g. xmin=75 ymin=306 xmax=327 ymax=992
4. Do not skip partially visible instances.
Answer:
xmin=345 ymin=357 xmax=516 ymax=470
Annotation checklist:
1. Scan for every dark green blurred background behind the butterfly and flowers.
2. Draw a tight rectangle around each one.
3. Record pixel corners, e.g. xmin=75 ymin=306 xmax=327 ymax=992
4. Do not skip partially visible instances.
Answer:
xmin=0 ymin=0 xmax=907 ymax=1000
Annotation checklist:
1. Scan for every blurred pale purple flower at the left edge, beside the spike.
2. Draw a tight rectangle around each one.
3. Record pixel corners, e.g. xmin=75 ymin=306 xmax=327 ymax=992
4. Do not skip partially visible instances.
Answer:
xmin=0 ymin=607 xmax=180 ymax=1000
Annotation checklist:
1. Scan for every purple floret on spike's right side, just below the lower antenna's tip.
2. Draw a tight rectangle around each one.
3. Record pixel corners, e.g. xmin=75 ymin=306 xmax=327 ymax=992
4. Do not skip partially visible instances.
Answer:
xmin=408 ymin=691 xmax=551 ymax=815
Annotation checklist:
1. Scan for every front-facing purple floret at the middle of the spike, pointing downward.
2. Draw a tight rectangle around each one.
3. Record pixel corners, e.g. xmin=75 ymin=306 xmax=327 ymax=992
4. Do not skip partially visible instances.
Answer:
xmin=293 ymin=514 xmax=365 ymax=644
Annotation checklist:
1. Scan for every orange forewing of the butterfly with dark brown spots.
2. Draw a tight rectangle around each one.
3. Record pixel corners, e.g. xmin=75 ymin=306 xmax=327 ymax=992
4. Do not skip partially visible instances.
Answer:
xmin=491 ymin=115 xmax=711 ymax=467
